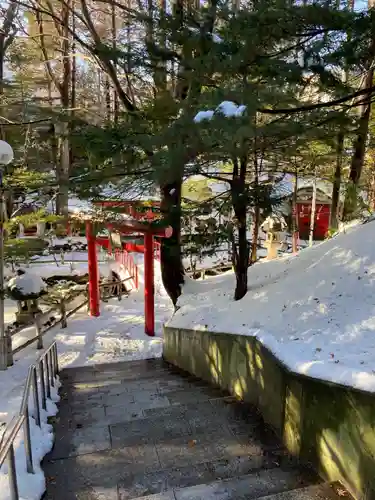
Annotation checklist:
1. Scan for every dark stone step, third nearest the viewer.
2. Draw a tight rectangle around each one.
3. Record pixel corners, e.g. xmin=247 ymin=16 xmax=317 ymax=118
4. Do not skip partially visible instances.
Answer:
xmin=44 ymin=451 xmax=306 ymax=500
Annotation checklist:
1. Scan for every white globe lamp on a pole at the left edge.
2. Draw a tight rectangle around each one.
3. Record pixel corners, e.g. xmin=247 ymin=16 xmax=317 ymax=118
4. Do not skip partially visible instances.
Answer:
xmin=0 ymin=141 xmax=14 ymax=370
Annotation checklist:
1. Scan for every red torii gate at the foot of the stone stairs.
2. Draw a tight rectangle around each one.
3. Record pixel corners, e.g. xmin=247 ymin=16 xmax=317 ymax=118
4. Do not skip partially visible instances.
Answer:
xmin=86 ymin=220 xmax=172 ymax=336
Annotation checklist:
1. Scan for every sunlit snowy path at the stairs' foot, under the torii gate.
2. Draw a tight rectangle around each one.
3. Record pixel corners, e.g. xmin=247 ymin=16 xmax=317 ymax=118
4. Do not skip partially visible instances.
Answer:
xmin=54 ymin=254 xmax=173 ymax=367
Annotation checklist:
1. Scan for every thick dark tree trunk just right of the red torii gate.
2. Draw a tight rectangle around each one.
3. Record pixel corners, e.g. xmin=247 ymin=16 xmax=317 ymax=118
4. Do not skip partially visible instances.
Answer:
xmin=160 ymin=180 xmax=184 ymax=306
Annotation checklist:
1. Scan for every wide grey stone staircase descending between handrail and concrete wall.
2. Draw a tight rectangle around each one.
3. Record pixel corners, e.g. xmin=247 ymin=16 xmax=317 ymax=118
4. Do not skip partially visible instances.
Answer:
xmin=43 ymin=360 xmax=345 ymax=500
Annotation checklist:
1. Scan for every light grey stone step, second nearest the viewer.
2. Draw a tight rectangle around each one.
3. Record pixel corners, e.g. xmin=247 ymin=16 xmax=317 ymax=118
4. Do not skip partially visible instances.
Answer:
xmin=129 ymin=468 xmax=313 ymax=500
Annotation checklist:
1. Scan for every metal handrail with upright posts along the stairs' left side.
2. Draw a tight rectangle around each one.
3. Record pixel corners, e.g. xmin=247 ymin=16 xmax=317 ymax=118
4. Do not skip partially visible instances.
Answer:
xmin=0 ymin=342 xmax=59 ymax=500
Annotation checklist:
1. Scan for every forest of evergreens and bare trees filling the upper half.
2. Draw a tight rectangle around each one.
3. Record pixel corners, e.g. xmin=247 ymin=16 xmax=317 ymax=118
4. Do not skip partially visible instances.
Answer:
xmin=0 ymin=0 xmax=375 ymax=304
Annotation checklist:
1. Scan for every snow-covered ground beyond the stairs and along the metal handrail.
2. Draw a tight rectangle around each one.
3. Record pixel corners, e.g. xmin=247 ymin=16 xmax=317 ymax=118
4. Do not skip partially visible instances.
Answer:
xmin=0 ymin=256 xmax=173 ymax=500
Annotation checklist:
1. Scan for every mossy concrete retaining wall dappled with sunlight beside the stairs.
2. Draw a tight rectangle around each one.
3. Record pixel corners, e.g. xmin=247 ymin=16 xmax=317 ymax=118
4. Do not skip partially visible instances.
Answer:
xmin=164 ymin=327 xmax=375 ymax=500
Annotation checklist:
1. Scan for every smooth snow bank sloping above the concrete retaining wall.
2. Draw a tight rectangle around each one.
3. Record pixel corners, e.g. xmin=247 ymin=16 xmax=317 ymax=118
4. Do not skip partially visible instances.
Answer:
xmin=168 ymin=222 xmax=375 ymax=392
